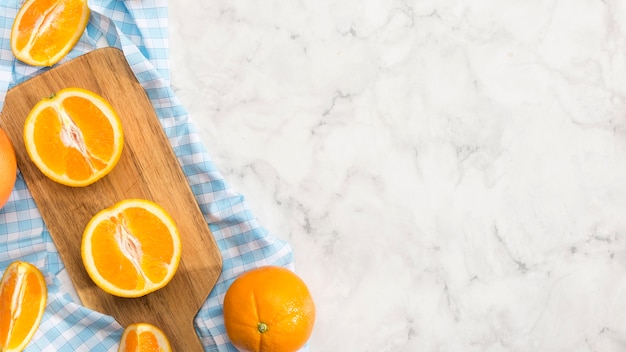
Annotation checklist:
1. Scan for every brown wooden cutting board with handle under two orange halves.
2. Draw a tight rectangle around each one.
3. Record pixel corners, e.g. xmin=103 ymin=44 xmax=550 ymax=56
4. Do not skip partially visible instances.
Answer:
xmin=0 ymin=48 xmax=222 ymax=352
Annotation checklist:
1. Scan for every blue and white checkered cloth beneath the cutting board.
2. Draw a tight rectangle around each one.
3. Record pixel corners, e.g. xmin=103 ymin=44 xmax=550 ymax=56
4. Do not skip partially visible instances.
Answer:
xmin=0 ymin=0 xmax=293 ymax=351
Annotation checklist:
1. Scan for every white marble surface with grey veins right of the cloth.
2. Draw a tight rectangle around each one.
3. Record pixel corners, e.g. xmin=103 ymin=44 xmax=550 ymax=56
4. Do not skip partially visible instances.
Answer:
xmin=170 ymin=0 xmax=626 ymax=352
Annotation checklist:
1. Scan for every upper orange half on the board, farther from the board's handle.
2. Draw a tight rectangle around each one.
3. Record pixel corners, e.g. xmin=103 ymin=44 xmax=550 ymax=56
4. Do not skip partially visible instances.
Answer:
xmin=24 ymin=88 xmax=124 ymax=187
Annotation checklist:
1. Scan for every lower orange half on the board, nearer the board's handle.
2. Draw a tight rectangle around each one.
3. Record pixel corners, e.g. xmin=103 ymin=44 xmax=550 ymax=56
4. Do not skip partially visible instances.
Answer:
xmin=81 ymin=199 xmax=182 ymax=297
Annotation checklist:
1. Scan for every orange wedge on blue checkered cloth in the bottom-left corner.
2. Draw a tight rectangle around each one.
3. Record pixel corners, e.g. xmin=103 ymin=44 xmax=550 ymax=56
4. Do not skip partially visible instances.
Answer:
xmin=0 ymin=261 xmax=48 ymax=352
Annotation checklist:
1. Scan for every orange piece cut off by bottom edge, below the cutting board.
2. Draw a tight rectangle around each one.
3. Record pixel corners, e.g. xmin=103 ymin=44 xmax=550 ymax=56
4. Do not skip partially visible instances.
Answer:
xmin=118 ymin=323 xmax=172 ymax=352
